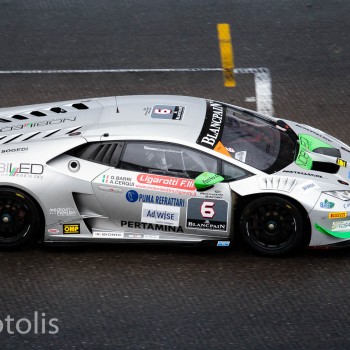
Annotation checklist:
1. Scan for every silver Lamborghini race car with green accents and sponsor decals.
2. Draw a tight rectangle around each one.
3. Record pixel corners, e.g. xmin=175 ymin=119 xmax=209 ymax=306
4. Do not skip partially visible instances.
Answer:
xmin=0 ymin=96 xmax=350 ymax=256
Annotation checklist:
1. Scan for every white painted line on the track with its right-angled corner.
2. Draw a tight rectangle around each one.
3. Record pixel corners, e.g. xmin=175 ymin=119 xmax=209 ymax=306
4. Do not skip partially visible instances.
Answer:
xmin=0 ymin=68 xmax=274 ymax=115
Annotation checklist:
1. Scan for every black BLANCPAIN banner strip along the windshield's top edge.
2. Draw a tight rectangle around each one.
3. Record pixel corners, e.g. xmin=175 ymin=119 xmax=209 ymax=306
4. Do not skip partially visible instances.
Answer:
xmin=197 ymin=101 xmax=226 ymax=149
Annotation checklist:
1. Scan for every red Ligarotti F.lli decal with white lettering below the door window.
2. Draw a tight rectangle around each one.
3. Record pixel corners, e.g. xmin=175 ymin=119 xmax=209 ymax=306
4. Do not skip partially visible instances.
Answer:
xmin=137 ymin=174 xmax=196 ymax=191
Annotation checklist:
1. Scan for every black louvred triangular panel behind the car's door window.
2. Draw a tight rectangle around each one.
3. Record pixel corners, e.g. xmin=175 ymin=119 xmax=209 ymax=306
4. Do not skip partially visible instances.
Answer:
xmin=68 ymin=142 xmax=123 ymax=167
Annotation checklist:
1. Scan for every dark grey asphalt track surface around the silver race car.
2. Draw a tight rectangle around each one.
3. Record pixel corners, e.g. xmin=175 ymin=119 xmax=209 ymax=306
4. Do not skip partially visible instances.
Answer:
xmin=0 ymin=0 xmax=350 ymax=350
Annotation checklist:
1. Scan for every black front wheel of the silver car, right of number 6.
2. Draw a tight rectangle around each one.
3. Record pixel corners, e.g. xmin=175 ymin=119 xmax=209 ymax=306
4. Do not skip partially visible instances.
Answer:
xmin=240 ymin=196 xmax=303 ymax=256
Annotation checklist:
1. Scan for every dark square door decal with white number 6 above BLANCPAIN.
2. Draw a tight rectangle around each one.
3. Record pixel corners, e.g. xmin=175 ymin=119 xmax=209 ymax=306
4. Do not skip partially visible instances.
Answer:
xmin=186 ymin=198 xmax=228 ymax=231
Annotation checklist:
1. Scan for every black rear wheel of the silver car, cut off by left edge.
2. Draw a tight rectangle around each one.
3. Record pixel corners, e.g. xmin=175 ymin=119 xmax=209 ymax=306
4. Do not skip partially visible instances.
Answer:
xmin=0 ymin=188 xmax=40 ymax=248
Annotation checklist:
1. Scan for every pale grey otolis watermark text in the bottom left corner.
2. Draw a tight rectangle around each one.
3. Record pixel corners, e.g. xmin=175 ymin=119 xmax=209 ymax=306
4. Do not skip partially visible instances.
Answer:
xmin=0 ymin=311 xmax=60 ymax=334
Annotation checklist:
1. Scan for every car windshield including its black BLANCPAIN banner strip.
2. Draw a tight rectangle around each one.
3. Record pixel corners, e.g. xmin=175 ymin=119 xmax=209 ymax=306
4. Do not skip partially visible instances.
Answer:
xmin=197 ymin=101 xmax=297 ymax=174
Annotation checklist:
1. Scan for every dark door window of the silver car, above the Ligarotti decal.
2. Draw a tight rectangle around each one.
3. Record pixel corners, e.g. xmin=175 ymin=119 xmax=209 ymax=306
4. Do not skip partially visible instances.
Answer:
xmin=119 ymin=142 xmax=218 ymax=179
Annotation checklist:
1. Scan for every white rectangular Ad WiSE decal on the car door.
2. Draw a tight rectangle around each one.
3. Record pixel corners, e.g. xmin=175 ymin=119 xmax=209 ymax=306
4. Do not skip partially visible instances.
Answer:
xmin=141 ymin=203 xmax=180 ymax=226
